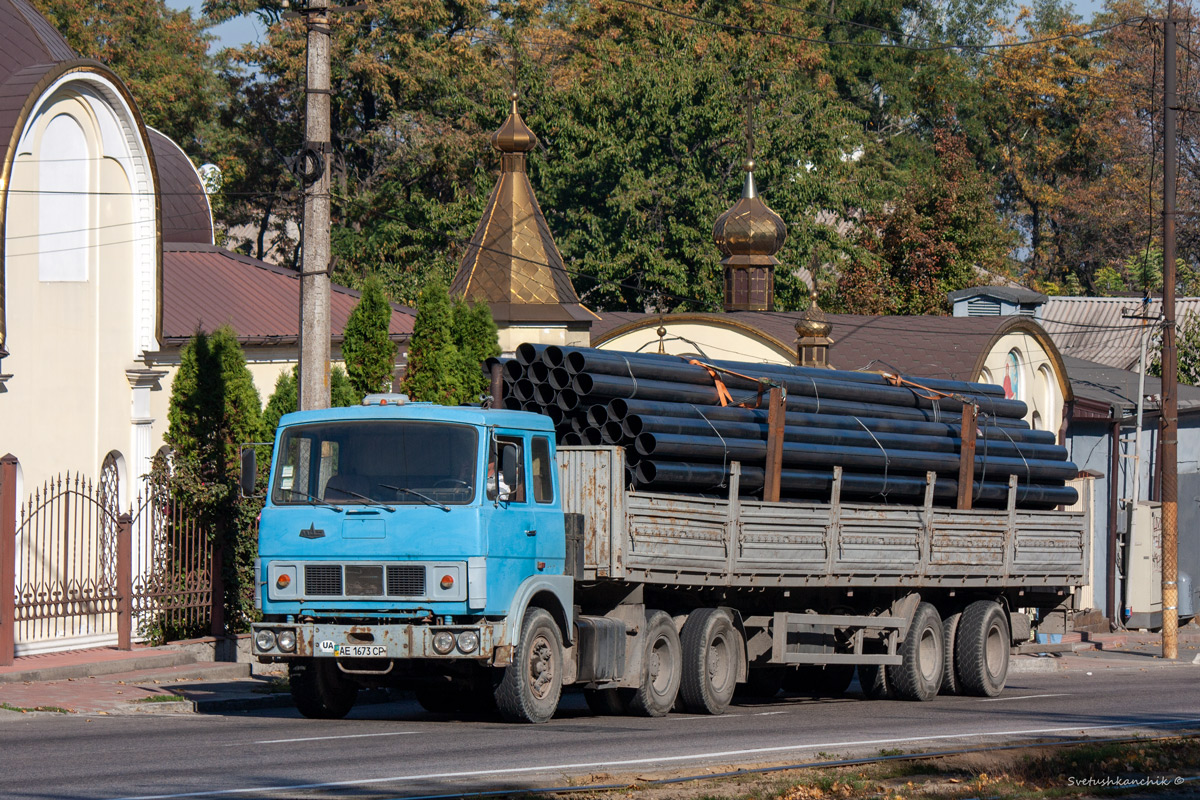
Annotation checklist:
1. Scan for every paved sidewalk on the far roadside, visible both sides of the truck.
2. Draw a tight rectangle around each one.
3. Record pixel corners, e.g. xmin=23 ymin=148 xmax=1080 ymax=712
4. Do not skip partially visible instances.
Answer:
xmin=0 ymin=626 xmax=1200 ymax=718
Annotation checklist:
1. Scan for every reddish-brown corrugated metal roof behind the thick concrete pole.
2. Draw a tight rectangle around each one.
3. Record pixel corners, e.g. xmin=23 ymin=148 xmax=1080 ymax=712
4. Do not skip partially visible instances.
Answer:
xmin=162 ymin=243 xmax=415 ymax=345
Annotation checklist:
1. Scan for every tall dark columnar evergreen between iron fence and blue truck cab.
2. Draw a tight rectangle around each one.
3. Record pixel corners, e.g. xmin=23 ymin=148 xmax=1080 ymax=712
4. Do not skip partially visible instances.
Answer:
xmin=166 ymin=326 xmax=264 ymax=632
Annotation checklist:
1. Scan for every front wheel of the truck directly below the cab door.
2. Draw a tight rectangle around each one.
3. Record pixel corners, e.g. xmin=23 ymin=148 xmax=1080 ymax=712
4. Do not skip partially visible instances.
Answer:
xmin=496 ymin=608 xmax=563 ymax=723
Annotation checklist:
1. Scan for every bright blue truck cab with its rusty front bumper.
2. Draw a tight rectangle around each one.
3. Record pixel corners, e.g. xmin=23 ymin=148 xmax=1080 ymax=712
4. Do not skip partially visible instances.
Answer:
xmin=253 ymin=395 xmax=574 ymax=721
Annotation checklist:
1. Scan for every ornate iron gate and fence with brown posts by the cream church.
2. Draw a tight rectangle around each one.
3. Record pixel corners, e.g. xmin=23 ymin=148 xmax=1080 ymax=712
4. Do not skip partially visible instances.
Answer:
xmin=0 ymin=457 xmax=221 ymax=664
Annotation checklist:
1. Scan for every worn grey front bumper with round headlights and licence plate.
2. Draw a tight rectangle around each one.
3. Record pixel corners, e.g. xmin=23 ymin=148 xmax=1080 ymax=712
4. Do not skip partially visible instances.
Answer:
xmin=251 ymin=620 xmax=504 ymax=661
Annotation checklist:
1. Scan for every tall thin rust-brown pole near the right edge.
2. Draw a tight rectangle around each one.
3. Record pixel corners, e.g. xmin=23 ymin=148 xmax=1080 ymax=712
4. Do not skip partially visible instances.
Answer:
xmin=1160 ymin=14 xmax=1180 ymax=658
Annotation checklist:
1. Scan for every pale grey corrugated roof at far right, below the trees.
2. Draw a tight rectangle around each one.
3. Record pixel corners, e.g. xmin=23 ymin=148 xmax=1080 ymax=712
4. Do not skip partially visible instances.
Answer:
xmin=1038 ymin=297 xmax=1200 ymax=369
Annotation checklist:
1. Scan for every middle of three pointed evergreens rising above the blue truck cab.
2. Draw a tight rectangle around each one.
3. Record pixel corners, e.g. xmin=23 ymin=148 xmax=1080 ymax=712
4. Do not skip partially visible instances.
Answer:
xmin=403 ymin=276 xmax=462 ymax=405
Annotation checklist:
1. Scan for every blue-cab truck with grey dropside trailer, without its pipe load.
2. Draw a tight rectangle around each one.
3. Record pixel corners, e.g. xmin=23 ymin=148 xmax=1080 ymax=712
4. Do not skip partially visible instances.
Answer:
xmin=244 ymin=395 xmax=1087 ymax=722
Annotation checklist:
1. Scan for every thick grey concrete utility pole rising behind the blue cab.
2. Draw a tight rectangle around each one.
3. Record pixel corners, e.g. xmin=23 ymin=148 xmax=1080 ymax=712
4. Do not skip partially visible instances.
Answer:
xmin=298 ymin=0 xmax=332 ymax=411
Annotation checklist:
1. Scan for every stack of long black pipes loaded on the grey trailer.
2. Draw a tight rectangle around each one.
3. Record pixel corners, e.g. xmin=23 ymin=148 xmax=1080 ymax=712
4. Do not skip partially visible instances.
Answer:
xmin=487 ymin=344 xmax=1076 ymax=509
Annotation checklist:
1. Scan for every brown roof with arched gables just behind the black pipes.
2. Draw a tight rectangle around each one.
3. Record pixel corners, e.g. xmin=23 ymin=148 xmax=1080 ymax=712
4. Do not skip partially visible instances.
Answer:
xmin=592 ymin=312 xmax=1052 ymax=380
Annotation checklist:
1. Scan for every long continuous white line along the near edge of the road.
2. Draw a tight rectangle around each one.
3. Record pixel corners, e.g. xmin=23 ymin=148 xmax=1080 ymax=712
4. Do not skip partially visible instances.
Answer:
xmin=115 ymin=717 xmax=1200 ymax=800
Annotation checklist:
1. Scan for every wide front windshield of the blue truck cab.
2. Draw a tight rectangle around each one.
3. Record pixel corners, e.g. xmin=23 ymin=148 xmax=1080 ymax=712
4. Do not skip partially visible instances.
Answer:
xmin=271 ymin=422 xmax=479 ymax=506
